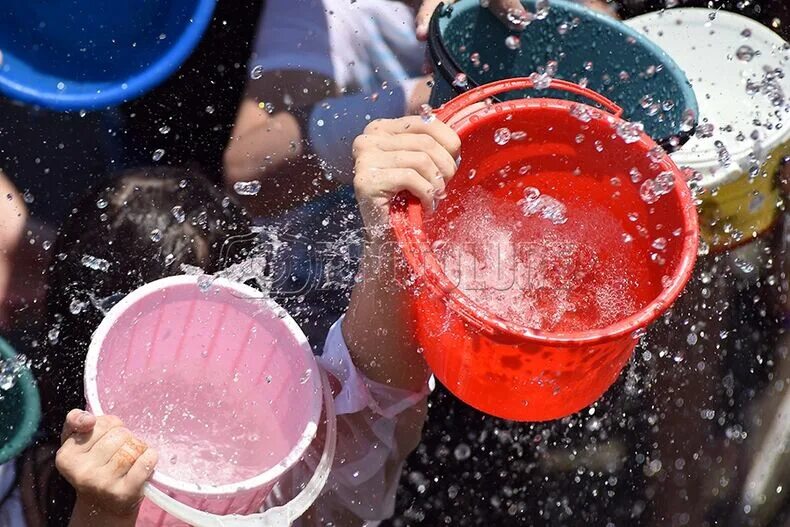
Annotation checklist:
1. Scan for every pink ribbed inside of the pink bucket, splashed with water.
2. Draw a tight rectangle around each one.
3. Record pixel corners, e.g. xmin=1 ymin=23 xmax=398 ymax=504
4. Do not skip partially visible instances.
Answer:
xmin=97 ymin=284 xmax=321 ymax=486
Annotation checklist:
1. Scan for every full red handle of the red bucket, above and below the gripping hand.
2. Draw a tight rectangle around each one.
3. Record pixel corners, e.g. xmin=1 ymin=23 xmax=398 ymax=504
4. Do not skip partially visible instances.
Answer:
xmin=391 ymin=77 xmax=623 ymax=338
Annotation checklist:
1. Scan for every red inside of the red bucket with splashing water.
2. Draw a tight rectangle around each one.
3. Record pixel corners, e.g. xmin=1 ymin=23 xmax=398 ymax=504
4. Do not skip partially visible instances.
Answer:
xmin=425 ymin=100 xmax=690 ymax=333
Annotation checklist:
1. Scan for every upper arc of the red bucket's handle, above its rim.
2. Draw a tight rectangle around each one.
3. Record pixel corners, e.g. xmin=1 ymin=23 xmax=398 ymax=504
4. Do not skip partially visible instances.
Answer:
xmin=434 ymin=77 xmax=623 ymax=122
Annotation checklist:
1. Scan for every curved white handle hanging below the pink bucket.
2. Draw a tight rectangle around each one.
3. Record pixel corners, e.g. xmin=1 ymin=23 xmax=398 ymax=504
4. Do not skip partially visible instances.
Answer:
xmin=144 ymin=369 xmax=337 ymax=527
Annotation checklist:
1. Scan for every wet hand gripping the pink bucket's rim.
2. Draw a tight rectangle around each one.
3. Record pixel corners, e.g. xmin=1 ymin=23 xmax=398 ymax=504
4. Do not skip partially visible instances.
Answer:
xmin=55 ymin=410 xmax=157 ymax=524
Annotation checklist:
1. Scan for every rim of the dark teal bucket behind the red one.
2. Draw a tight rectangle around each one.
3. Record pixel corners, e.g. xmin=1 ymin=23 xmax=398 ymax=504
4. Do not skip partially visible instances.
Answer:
xmin=427 ymin=0 xmax=699 ymax=152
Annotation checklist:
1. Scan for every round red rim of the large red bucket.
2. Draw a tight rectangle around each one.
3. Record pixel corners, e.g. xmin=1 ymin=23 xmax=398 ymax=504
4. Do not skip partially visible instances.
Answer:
xmin=390 ymin=98 xmax=699 ymax=347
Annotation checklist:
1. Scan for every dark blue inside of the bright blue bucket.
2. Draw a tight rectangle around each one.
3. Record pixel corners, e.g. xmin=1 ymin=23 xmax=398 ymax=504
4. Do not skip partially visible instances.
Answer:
xmin=0 ymin=0 xmax=197 ymax=85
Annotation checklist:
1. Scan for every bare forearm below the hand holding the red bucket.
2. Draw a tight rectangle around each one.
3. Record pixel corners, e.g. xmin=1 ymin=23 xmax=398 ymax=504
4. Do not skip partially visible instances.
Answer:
xmin=343 ymin=240 xmax=430 ymax=391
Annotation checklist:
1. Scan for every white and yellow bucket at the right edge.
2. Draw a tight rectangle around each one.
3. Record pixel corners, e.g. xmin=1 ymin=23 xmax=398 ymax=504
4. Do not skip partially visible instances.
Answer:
xmin=628 ymin=8 xmax=790 ymax=258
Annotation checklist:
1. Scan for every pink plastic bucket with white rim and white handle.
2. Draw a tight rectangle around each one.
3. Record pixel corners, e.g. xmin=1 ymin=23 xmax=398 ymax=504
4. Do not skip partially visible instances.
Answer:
xmin=85 ymin=276 xmax=336 ymax=526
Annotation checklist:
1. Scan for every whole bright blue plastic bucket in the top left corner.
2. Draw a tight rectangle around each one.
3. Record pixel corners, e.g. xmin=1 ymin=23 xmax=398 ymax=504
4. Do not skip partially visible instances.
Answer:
xmin=0 ymin=0 xmax=215 ymax=110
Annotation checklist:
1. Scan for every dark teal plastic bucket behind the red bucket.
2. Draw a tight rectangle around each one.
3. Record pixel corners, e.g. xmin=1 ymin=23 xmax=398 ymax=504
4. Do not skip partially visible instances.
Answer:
xmin=428 ymin=0 xmax=698 ymax=151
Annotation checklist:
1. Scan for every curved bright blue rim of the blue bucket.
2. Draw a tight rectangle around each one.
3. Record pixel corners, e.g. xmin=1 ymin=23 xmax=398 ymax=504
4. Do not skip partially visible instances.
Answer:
xmin=0 ymin=0 xmax=217 ymax=111
